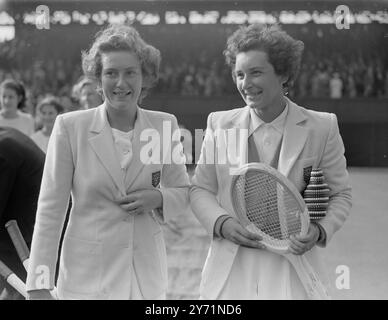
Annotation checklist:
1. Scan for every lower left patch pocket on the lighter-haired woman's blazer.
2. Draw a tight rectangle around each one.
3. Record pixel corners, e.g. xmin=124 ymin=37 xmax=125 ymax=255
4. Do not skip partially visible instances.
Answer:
xmin=58 ymin=236 xmax=102 ymax=294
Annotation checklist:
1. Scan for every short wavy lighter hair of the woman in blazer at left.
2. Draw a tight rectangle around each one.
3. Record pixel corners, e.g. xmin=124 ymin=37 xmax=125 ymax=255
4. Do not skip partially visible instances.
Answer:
xmin=82 ymin=25 xmax=161 ymax=97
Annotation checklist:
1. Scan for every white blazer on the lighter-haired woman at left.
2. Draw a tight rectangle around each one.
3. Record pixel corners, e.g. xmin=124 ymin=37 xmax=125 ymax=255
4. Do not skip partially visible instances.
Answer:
xmin=27 ymin=104 xmax=189 ymax=299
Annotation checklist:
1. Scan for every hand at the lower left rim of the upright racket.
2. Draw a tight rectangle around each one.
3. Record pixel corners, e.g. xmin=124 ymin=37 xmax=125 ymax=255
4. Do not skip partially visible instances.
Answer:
xmin=221 ymin=218 xmax=265 ymax=249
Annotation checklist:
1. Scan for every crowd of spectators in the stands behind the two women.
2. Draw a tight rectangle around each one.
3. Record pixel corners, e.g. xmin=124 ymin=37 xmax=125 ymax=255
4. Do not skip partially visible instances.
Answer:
xmin=0 ymin=26 xmax=388 ymax=117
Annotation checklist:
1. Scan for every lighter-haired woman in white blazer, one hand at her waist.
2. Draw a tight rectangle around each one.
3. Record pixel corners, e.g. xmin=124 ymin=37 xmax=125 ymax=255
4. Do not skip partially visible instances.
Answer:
xmin=27 ymin=26 xmax=189 ymax=299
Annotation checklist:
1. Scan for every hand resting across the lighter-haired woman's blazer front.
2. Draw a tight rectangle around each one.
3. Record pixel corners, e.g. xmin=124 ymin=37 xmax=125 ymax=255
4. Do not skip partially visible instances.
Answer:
xmin=117 ymin=189 xmax=163 ymax=215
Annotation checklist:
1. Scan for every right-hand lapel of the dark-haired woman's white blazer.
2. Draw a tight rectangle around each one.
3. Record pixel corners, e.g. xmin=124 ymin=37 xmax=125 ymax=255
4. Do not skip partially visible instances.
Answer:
xmin=278 ymin=99 xmax=307 ymax=177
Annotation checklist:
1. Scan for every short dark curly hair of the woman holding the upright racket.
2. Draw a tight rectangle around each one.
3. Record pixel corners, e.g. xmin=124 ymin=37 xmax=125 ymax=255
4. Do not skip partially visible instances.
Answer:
xmin=224 ymin=24 xmax=304 ymax=87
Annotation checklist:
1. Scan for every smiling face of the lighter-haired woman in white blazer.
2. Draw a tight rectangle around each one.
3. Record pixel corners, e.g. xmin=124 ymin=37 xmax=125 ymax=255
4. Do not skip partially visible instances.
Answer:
xmin=101 ymin=51 xmax=143 ymax=110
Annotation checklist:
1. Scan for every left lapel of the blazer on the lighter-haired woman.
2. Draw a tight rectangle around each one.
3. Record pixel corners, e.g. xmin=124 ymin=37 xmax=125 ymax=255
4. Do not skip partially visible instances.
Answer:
xmin=89 ymin=104 xmax=125 ymax=195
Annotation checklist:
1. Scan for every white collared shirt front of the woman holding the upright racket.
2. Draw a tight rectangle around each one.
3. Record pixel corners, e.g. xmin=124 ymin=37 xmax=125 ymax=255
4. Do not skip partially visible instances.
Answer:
xmin=249 ymin=102 xmax=288 ymax=164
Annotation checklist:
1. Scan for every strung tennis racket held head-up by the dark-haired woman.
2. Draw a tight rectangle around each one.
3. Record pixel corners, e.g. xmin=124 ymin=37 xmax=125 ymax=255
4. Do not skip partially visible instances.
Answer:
xmin=231 ymin=163 xmax=330 ymax=300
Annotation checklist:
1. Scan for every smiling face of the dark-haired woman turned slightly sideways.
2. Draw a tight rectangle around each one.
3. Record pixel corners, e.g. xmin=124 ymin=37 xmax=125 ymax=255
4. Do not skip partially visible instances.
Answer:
xmin=234 ymin=50 xmax=286 ymax=121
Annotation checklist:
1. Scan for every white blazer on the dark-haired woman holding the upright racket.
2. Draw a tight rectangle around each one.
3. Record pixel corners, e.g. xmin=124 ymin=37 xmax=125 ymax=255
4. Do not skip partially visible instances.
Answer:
xmin=190 ymin=100 xmax=351 ymax=299
